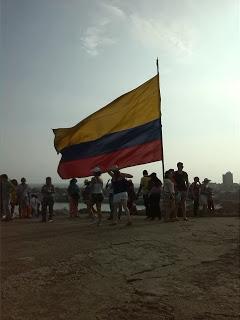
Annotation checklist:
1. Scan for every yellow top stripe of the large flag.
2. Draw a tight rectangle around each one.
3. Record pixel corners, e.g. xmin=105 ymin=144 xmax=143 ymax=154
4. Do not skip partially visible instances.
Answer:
xmin=53 ymin=75 xmax=160 ymax=151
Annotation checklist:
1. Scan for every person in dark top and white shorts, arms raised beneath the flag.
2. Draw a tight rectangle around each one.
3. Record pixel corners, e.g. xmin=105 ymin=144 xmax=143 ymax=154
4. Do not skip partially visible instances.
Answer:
xmin=108 ymin=165 xmax=133 ymax=225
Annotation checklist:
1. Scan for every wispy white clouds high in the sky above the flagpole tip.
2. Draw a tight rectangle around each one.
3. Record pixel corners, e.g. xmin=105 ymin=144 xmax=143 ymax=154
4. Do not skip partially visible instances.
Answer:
xmin=81 ymin=2 xmax=194 ymax=58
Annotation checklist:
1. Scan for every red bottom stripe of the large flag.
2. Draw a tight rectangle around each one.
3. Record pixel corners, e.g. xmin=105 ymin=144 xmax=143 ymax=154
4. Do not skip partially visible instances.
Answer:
xmin=58 ymin=140 xmax=162 ymax=179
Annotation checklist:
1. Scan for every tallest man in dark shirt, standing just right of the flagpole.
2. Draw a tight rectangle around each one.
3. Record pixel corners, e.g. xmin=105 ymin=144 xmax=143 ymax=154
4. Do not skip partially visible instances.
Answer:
xmin=174 ymin=162 xmax=189 ymax=220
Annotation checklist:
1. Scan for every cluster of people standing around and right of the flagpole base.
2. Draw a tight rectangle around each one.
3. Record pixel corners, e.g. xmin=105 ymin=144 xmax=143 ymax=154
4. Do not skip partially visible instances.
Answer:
xmin=138 ymin=162 xmax=214 ymax=222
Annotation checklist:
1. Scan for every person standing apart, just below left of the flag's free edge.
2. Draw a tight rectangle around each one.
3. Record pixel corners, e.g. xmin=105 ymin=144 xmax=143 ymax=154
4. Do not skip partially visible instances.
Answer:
xmin=41 ymin=177 xmax=55 ymax=222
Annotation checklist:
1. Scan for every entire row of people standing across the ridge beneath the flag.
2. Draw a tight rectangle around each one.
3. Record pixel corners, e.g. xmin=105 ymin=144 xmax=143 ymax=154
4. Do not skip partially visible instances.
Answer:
xmin=0 ymin=162 xmax=214 ymax=225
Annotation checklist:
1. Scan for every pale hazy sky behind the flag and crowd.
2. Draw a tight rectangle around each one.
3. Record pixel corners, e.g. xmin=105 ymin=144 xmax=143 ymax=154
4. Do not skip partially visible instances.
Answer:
xmin=0 ymin=0 xmax=240 ymax=183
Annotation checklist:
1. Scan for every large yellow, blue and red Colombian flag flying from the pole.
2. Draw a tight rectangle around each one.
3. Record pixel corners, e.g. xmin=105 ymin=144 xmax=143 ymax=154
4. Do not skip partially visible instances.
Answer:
xmin=53 ymin=74 xmax=162 ymax=179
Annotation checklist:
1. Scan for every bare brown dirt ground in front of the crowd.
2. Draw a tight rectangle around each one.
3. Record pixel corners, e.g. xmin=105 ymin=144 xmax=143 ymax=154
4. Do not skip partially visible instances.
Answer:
xmin=1 ymin=216 xmax=240 ymax=320
